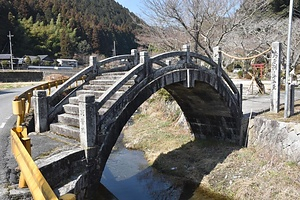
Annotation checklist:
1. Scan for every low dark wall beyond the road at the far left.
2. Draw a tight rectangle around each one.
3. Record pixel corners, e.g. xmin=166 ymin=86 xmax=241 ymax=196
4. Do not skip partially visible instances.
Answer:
xmin=0 ymin=71 xmax=44 ymax=82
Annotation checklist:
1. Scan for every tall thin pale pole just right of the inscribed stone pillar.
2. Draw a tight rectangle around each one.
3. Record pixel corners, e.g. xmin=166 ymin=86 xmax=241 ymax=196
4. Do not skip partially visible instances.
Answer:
xmin=284 ymin=0 xmax=294 ymax=118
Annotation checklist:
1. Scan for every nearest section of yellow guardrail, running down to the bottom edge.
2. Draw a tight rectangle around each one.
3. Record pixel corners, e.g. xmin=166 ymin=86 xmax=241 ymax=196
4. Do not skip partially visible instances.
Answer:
xmin=11 ymin=126 xmax=76 ymax=200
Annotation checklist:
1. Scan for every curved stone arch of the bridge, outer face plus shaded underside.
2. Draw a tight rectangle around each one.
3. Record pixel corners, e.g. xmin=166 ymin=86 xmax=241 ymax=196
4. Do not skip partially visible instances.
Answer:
xmin=98 ymin=66 xmax=241 ymax=174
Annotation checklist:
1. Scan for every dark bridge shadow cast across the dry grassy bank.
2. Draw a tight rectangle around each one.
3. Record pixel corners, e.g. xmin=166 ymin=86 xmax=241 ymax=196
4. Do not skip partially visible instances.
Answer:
xmin=153 ymin=140 xmax=241 ymax=200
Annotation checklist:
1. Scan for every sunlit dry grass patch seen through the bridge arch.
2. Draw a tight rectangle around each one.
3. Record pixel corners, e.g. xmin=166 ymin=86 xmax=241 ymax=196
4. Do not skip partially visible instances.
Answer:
xmin=123 ymin=93 xmax=193 ymax=164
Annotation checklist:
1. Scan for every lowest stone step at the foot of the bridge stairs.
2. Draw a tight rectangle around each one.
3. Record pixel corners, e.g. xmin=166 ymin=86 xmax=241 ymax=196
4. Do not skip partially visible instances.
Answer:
xmin=50 ymin=123 xmax=80 ymax=141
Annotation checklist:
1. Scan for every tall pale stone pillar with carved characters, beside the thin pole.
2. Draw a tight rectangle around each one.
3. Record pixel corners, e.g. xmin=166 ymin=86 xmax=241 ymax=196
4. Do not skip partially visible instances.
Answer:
xmin=270 ymin=42 xmax=282 ymax=113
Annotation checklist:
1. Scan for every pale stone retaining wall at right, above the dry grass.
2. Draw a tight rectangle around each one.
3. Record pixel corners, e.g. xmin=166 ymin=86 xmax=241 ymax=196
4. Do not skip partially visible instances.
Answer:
xmin=248 ymin=117 xmax=300 ymax=164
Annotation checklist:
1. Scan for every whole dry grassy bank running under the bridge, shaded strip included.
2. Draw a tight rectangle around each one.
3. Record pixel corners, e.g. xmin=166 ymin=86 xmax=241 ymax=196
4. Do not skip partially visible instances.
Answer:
xmin=124 ymin=91 xmax=300 ymax=200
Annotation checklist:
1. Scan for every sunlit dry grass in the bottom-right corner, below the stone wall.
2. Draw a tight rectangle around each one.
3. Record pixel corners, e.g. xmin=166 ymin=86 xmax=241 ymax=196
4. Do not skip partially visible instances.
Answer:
xmin=202 ymin=148 xmax=300 ymax=200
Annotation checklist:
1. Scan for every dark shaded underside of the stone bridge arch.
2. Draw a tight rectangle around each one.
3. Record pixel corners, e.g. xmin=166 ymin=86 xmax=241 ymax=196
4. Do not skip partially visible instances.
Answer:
xmin=165 ymin=81 xmax=239 ymax=142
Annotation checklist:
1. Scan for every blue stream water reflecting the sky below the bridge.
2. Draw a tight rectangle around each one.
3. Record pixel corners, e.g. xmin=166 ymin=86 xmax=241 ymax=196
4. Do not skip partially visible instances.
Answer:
xmin=101 ymin=148 xmax=181 ymax=200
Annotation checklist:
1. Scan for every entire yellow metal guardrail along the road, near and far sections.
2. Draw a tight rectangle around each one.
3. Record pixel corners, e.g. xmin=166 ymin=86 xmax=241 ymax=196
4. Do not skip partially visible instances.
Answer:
xmin=11 ymin=79 xmax=84 ymax=200
